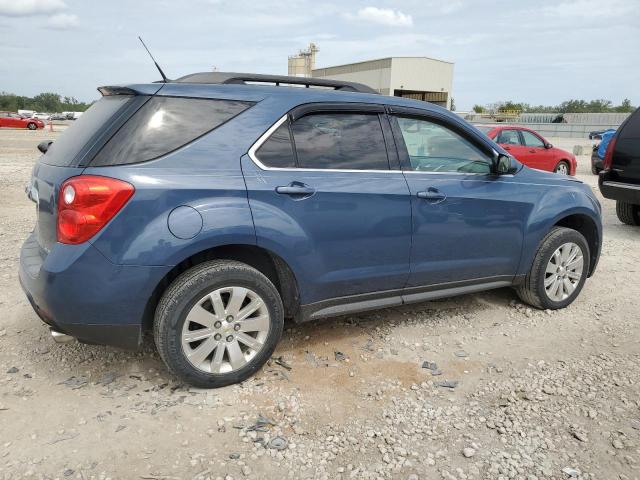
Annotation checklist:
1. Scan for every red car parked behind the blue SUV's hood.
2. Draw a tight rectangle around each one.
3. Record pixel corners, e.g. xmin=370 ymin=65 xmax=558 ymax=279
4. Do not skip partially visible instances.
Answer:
xmin=478 ymin=125 xmax=578 ymax=175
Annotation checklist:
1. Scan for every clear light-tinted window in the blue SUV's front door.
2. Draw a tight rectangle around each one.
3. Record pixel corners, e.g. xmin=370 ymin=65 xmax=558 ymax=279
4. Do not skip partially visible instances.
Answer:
xmin=396 ymin=117 xmax=491 ymax=173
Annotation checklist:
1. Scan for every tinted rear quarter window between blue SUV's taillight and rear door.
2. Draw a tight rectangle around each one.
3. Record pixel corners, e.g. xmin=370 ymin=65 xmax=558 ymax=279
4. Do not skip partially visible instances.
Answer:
xmin=92 ymin=97 xmax=253 ymax=166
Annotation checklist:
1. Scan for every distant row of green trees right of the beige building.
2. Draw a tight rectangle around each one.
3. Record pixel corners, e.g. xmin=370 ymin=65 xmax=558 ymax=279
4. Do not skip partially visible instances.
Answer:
xmin=473 ymin=98 xmax=636 ymax=113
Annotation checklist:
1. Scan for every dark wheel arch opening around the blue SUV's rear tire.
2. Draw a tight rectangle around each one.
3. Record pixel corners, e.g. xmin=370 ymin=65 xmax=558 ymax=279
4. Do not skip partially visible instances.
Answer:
xmin=142 ymin=244 xmax=300 ymax=330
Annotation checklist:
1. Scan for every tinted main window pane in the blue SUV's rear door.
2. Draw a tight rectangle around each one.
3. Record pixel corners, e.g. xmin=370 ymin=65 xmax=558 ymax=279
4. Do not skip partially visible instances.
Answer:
xmin=291 ymin=113 xmax=389 ymax=170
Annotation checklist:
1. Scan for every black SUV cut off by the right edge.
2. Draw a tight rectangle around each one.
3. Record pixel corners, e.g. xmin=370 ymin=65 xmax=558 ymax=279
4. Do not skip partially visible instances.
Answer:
xmin=598 ymin=108 xmax=640 ymax=225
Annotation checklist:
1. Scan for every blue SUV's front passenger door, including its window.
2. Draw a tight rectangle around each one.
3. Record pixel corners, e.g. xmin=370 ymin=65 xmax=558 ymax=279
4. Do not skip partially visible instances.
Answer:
xmin=392 ymin=109 xmax=531 ymax=287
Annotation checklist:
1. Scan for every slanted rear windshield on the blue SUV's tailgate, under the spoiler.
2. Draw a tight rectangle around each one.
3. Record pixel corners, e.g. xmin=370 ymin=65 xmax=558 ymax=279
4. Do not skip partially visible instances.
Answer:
xmin=40 ymin=95 xmax=133 ymax=167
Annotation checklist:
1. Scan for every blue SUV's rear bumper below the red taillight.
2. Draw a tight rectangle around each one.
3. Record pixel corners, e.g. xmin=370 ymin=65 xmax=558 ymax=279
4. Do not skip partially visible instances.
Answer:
xmin=20 ymin=234 xmax=169 ymax=350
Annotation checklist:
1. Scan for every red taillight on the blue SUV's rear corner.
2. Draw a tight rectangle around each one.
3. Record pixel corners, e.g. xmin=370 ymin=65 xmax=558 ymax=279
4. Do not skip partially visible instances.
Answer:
xmin=58 ymin=175 xmax=135 ymax=244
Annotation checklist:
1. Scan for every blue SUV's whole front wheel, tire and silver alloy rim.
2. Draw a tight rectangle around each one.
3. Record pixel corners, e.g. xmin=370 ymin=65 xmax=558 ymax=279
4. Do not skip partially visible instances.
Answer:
xmin=516 ymin=227 xmax=590 ymax=310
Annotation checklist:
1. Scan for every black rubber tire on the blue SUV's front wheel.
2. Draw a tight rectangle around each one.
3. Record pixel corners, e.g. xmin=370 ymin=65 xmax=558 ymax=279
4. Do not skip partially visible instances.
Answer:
xmin=516 ymin=227 xmax=591 ymax=310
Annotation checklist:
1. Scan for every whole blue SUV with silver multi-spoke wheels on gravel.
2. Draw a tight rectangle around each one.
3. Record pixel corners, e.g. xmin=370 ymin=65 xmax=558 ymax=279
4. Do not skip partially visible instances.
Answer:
xmin=20 ymin=72 xmax=602 ymax=387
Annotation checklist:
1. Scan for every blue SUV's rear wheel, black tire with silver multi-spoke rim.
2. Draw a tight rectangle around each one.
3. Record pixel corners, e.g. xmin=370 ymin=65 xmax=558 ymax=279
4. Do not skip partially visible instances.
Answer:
xmin=153 ymin=260 xmax=284 ymax=388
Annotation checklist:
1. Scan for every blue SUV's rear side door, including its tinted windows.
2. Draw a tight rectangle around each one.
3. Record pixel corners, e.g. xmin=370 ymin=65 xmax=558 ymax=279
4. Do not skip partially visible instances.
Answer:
xmin=242 ymin=104 xmax=411 ymax=304
